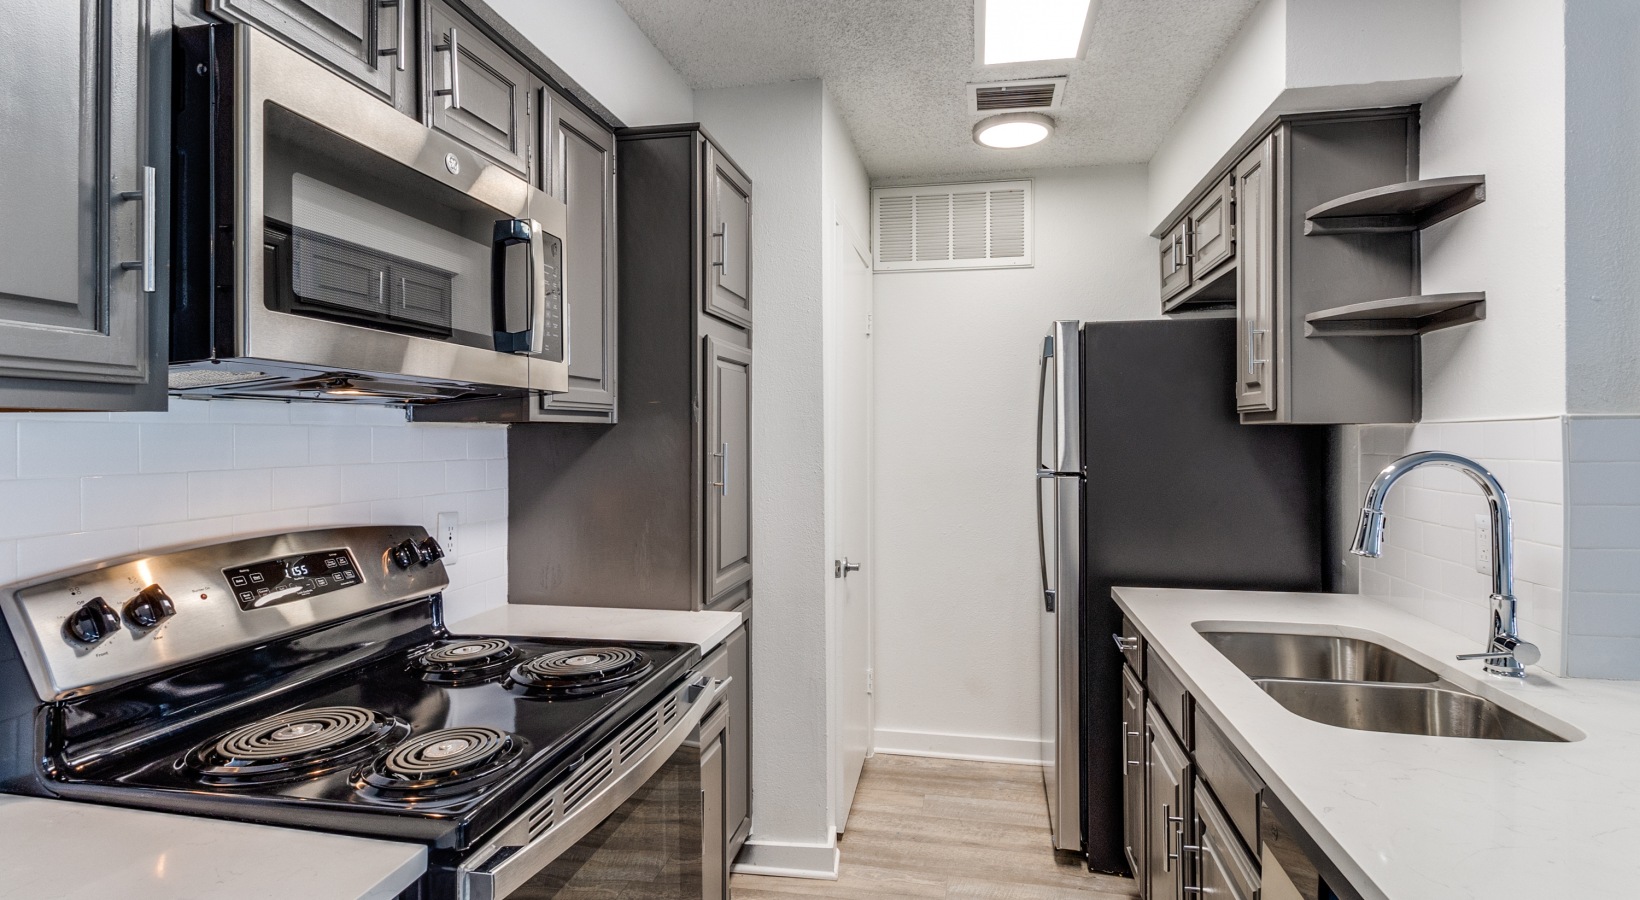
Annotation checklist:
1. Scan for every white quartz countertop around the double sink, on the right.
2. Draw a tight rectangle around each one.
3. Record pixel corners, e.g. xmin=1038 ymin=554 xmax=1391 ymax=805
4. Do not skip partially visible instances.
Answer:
xmin=1114 ymin=587 xmax=1640 ymax=900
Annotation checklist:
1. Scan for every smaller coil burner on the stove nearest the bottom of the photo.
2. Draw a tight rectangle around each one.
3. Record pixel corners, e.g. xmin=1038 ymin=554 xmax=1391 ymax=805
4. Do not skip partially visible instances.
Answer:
xmin=354 ymin=726 xmax=528 ymax=802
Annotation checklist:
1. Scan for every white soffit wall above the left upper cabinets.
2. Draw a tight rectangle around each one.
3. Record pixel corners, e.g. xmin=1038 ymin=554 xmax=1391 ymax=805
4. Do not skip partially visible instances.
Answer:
xmin=489 ymin=0 xmax=695 ymax=126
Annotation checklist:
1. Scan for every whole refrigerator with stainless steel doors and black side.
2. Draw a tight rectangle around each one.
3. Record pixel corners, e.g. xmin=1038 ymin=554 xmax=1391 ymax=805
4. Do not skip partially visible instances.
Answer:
xmin=1036 ymin=318 xmax=1342 ymax=872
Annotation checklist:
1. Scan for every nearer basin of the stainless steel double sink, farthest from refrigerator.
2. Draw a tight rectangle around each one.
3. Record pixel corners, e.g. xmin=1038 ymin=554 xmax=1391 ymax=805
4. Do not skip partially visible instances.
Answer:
xmin=1253 ymin=678 xmax=1566 ymax=743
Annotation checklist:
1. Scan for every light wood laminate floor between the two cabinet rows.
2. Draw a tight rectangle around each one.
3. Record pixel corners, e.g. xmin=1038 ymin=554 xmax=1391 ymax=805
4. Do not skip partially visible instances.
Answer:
xmin=730 ymin=754 xmax=1138 ymax=900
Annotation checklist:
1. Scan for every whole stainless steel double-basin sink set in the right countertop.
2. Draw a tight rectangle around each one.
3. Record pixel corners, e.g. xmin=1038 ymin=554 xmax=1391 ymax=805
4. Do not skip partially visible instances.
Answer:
xmin=1200 ymin=631 xmax=1566 ymax=741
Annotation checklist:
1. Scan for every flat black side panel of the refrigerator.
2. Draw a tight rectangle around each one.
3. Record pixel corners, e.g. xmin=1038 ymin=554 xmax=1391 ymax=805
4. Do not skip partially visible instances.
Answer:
xmin=1082 ymin=318 xmax=1330 ymax=872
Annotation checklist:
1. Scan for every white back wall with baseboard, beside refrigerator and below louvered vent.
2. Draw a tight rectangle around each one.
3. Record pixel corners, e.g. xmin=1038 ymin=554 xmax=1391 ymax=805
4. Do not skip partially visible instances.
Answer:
xmin=872 ymin=166 xmax=1161 ymax=761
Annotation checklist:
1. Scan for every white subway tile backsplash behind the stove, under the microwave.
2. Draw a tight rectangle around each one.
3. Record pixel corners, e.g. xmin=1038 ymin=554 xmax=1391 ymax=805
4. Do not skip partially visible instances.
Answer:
xmin=0 ymin=400 xmax=507 ymax=618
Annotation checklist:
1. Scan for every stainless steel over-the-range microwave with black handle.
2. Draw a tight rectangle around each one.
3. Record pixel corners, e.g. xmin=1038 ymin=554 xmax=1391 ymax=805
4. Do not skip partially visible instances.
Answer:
xmin=169 ymin=25 xmax=569 ymax=403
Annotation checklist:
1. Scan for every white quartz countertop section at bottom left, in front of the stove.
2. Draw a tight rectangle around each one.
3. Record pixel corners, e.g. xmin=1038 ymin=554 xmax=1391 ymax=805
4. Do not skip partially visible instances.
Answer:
xmin=0 ymin=795 xmax=426 ymax=900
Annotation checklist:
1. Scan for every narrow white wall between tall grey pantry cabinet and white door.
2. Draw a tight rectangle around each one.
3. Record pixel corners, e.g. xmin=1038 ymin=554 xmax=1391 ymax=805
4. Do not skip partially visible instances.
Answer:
xmin=695 ymin=80 xmax=835 ymax=867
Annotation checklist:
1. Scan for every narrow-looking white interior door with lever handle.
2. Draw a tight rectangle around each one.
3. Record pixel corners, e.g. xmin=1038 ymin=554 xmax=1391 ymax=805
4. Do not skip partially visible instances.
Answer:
xmin=828 ymin=221 xmax=872 ymax=831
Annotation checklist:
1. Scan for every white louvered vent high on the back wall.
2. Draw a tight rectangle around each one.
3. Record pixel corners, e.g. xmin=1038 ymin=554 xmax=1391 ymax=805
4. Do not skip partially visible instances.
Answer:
xmin=871 ymin=180 xmax=1032 ymax=272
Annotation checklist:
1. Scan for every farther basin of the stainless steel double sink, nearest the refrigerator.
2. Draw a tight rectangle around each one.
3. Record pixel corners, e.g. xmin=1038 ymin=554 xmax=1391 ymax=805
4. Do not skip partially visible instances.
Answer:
xmin=1200 ymin=631 xmax=1440 ymax=684
